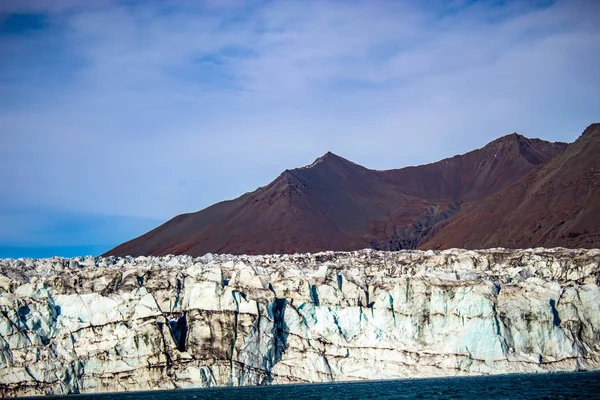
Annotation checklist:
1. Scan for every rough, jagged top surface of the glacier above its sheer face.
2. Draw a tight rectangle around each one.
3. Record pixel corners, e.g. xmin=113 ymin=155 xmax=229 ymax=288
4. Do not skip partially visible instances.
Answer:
xmin=0 ymin=247 xmax=600 ymax=283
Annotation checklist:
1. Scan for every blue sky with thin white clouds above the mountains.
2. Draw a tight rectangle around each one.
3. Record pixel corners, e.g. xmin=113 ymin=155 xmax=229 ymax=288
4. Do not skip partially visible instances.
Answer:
xmin=0 ymin=0 xmax=600 ymax=257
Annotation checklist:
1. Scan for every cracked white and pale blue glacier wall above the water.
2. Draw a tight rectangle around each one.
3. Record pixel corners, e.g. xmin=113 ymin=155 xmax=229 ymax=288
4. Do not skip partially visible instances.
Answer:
xmin=0 ymin=249 xmax=600 ymax=396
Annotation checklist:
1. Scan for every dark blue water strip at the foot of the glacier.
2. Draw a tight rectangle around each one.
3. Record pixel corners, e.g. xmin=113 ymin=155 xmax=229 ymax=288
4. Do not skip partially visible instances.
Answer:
xmin=30 ymin=372 xmax=600 ymax=400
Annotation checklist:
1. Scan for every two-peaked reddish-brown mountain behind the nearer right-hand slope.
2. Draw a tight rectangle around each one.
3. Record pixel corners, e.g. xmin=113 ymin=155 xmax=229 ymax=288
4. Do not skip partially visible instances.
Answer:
xmin=105 ymin=134 xmax=566 ymax=256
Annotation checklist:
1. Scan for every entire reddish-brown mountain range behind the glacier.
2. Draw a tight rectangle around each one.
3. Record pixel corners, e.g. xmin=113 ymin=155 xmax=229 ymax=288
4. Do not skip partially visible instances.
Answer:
xmin=106 ymin=124 xmax=600 ymax=256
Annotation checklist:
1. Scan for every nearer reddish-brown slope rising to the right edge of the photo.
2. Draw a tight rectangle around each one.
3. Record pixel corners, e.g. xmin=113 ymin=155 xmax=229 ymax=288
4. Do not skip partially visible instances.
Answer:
xmin=420 ymin=123 xmax=600 ymax=249
